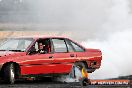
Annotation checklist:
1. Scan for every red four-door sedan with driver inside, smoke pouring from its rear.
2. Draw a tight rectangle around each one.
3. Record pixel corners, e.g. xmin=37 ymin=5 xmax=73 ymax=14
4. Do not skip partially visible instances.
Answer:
xmin=0 ymin=37 xmax=102 ymax=84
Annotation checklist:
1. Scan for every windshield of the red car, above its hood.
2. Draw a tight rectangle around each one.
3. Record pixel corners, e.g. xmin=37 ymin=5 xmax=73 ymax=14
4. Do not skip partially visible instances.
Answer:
xmin=0 ymin=38 xmax=33 ymax=52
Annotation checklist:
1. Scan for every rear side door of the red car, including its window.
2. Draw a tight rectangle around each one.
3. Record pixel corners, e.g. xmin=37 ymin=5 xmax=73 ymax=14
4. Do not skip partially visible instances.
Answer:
xmin=52 ymin=38 xmax=76 ymax=73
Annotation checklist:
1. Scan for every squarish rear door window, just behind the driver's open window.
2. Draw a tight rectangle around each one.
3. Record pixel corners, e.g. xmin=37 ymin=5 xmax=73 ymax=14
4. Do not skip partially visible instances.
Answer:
xmin=52 ymin=39 xmax=67 ymax=53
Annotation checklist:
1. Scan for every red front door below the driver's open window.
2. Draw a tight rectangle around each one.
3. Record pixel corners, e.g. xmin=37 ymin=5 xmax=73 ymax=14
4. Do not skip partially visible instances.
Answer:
xmin=21 ymin=39 xmax=53 ymax=74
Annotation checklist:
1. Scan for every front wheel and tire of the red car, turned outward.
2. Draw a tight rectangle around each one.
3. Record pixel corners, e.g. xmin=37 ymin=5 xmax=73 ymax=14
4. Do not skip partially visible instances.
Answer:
xmin=3 ymin=63 xmax=15 ymax=84
